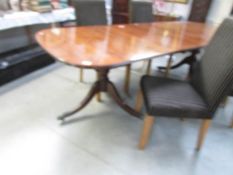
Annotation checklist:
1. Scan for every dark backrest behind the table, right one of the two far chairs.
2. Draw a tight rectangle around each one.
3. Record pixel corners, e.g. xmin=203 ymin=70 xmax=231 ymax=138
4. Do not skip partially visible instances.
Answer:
xmin=130 ymin=0 xmax=154 ymax=23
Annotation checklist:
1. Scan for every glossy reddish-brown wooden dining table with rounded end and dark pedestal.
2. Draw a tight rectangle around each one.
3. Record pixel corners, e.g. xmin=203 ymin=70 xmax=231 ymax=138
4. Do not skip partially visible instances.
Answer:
xmin=35 ymin=21 xmax=216 ymax=121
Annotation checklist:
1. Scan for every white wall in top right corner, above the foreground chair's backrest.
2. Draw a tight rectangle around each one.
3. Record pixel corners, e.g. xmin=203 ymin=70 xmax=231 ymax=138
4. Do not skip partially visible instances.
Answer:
xmin=207 ymin=0 xmax=233 ymax=24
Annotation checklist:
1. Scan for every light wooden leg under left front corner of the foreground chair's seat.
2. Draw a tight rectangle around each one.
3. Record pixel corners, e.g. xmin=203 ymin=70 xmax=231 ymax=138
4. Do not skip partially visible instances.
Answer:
xmin=138 ymin=115 xmax=155 ymax=149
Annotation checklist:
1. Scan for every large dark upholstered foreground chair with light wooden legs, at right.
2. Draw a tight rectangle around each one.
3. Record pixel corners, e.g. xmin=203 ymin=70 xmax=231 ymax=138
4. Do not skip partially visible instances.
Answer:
xmin=139 ymin=18 xmax=233 ymax=150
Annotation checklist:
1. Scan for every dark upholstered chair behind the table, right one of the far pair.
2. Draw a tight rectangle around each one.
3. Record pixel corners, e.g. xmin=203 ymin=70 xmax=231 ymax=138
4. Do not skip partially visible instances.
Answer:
xmin=124 ymin=0 xmax=154 ymax=94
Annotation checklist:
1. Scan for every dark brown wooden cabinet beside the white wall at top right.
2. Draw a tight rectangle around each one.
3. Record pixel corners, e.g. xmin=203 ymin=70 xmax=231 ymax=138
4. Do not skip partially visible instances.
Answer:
xmin=189 ymin=0 xmax=212 ymax=22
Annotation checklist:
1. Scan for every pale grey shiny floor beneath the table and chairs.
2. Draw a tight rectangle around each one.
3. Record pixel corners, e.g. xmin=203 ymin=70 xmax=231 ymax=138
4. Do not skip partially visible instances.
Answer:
xmin=0 ymin=56 xmax=233 ymax=175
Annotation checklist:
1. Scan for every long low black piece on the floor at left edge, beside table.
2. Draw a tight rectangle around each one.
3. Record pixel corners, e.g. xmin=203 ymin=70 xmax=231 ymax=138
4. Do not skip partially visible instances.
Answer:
xmin=0 ymin=45 xmax=54 ymax=85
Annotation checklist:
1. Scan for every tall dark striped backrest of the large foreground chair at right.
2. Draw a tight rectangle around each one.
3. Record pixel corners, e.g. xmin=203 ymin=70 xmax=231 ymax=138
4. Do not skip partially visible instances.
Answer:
xmin=191 ymin=18 xmax=233 ymax=113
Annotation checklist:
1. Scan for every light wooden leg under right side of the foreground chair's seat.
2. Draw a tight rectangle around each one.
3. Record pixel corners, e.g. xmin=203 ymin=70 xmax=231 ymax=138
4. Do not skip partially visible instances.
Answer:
xmin=196 ymin=119 xmax=211 ymax=151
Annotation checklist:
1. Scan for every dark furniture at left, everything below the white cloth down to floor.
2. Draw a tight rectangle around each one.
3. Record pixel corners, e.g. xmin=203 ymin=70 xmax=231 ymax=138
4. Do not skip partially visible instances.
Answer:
xmin=0 ymin=25 xmax=54 ymax=85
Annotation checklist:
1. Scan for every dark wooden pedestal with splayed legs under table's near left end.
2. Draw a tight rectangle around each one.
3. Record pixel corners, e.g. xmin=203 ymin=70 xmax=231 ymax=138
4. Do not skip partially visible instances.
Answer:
xmin=58 ymin=68 xmax=141 ymax=120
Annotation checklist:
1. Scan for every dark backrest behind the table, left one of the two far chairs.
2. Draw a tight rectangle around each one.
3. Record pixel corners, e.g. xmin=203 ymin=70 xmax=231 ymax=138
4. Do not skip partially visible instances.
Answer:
xmin=72 ymin=0 xmax=107 ymax=26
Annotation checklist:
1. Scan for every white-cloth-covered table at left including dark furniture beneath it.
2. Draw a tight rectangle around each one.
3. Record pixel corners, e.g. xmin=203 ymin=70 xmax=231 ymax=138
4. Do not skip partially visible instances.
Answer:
xmin=0 ymin=8 xmax=75 ymax=85
